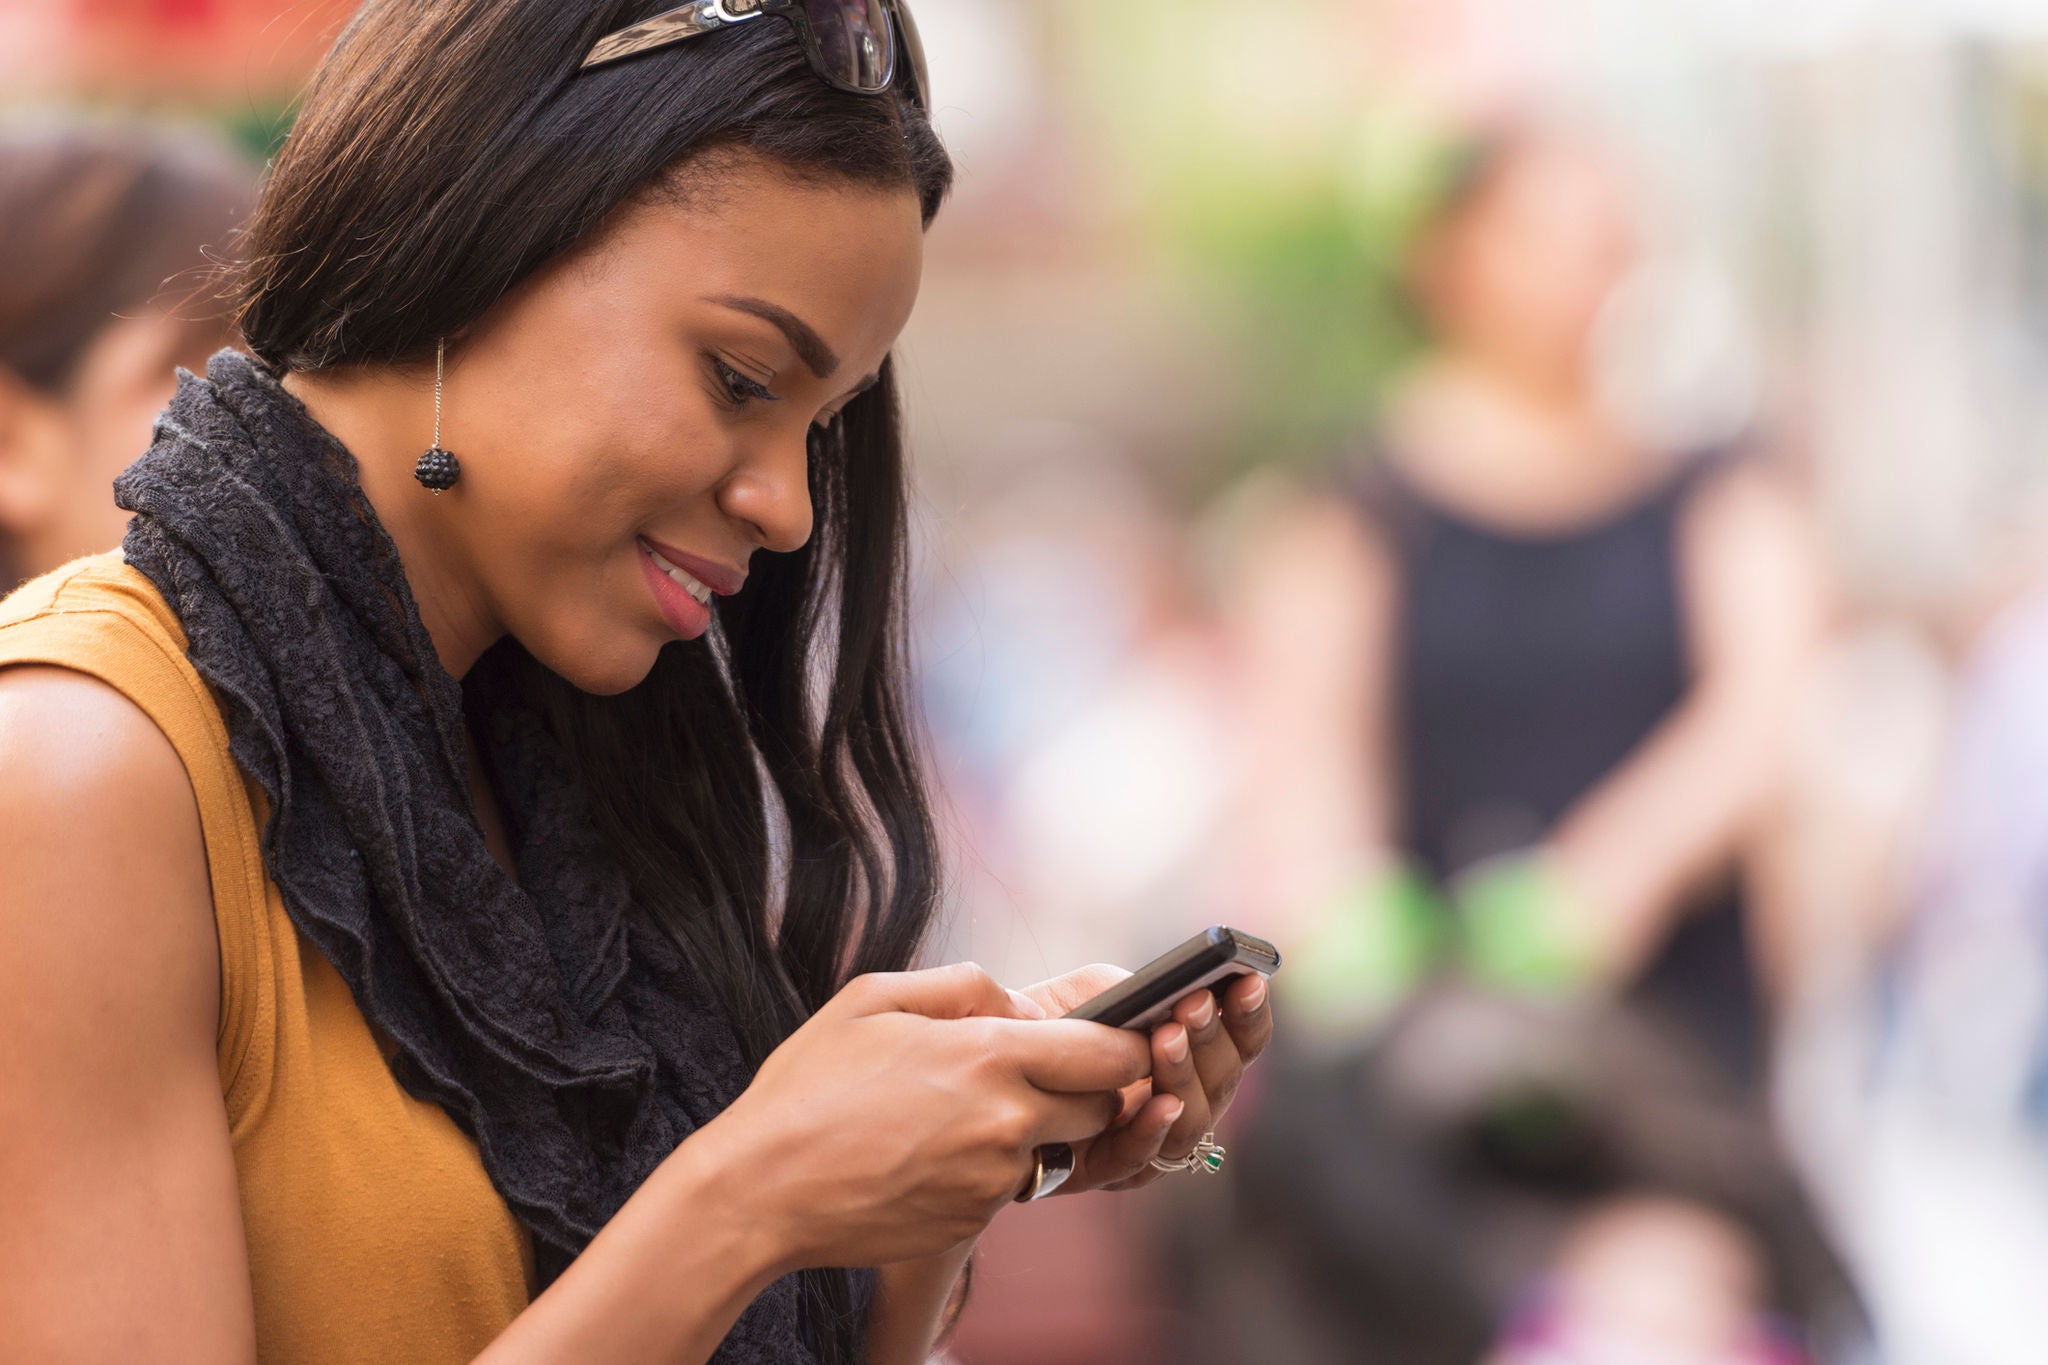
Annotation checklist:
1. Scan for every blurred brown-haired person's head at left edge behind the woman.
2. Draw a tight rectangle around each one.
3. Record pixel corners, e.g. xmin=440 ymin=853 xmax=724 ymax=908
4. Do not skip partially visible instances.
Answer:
xmin=0 ymin=121 xmax=254 ymax=591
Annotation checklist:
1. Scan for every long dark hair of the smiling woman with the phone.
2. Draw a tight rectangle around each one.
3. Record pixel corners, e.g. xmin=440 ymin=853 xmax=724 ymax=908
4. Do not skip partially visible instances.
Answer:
xmin=236 ymin=0 xmax=952 ymax=1349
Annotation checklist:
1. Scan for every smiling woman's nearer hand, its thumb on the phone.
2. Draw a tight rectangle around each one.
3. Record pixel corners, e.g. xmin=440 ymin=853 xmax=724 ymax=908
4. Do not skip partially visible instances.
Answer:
xmin=700 ymin=964 xmax=1155 ymax=1271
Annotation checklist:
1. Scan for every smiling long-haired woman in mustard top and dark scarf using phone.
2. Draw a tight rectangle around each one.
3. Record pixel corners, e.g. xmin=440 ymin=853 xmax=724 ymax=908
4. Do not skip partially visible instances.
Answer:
xmin=0 ymin=0 xmax=1268 ymax=1365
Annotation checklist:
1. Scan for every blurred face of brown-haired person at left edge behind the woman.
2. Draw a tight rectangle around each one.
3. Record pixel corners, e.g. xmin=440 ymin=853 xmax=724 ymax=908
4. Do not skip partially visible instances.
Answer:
xmin=0 ymin=313 xmax=227 ymax=591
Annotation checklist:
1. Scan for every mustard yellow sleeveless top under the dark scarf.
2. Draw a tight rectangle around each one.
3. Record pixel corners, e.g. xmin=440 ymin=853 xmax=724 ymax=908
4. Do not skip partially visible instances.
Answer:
xmin=0 ymin=555 xmax=532 ymax=1365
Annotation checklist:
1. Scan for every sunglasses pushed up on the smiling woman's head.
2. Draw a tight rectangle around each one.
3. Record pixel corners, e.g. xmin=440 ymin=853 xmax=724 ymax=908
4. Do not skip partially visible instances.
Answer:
xmin=580 ymin=0 xmax=932 ymax=111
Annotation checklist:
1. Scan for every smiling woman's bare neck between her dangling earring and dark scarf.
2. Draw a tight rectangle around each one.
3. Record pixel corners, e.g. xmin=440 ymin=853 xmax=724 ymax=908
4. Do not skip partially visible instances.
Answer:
xmin=285 ymin=368 xmax=504 ymax=677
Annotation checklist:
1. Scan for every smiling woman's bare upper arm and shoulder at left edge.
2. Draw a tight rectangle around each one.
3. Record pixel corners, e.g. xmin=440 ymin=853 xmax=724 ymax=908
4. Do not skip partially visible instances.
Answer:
xmin=0 ymin=667 xmax=256 ymax=1365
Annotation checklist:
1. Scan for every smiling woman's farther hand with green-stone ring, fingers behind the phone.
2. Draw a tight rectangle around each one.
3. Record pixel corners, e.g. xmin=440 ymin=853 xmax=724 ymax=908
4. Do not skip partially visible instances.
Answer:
xmin=1024 ymin=964 xmax=1274 ymax=1193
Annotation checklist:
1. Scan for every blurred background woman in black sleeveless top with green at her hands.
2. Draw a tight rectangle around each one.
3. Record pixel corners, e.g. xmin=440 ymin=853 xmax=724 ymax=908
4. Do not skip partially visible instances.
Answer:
xmin=1171 ymin=125 xmax=1839 ymax=1365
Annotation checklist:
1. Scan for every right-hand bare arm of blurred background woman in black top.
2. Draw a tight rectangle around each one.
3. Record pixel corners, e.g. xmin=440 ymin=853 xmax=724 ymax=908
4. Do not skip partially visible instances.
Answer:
xmin=1546 ymin=469 xmax=1827 ymax=978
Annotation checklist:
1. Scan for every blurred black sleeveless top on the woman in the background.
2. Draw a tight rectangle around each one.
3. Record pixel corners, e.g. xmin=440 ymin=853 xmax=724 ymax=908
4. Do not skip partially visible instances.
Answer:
xmin=1354 ymin=458 xmax=1761 ymax=1083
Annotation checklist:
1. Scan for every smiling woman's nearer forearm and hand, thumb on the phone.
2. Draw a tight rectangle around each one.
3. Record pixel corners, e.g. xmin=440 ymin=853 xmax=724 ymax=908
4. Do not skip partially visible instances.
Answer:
xmin=481 ymin=964 xmax=1149 ymax=1365
